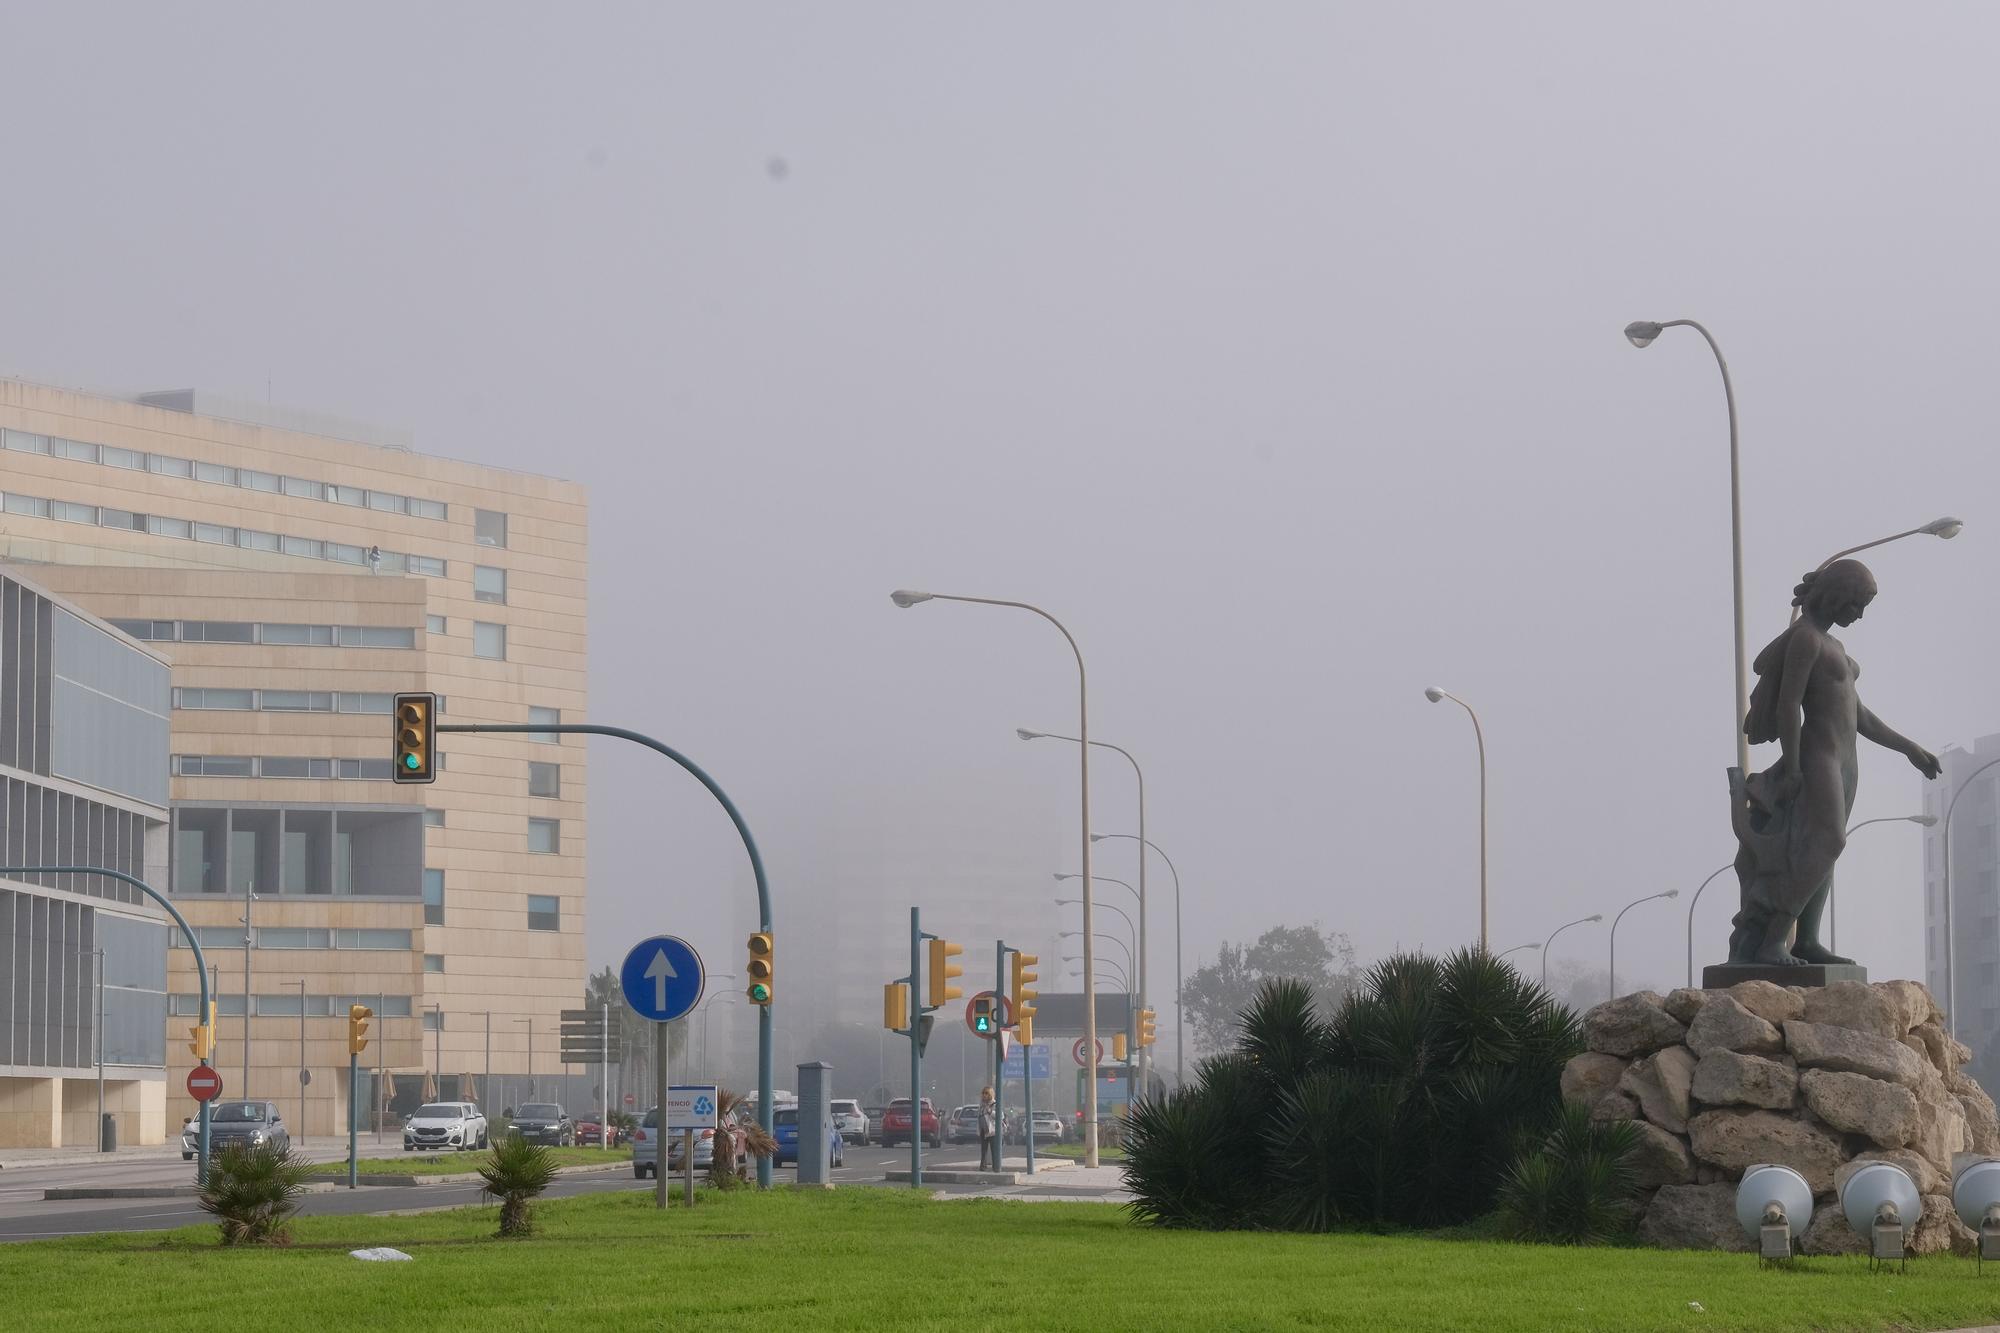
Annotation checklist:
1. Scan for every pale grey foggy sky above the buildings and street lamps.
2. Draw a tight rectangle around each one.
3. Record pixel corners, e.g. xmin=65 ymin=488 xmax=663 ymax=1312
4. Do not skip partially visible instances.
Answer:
xmin=0 ymin=0 xmax=2000 ymax=1027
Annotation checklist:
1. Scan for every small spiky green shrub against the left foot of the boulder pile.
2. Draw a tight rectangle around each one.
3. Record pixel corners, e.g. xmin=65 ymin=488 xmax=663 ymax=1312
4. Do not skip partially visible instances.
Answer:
xmin=1500 ymin=1107 xmax=1638 ymax=1245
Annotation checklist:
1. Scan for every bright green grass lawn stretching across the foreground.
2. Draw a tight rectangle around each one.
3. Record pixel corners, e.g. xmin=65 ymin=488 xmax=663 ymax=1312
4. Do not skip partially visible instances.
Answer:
xmin=11 ymin=1189 xmax=2000 ymax=1333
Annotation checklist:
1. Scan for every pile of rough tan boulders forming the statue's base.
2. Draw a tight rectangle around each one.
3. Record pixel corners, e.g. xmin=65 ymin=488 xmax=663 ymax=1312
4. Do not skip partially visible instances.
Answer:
xmin=1562 ymin=981 xmax=2000 ymax=1255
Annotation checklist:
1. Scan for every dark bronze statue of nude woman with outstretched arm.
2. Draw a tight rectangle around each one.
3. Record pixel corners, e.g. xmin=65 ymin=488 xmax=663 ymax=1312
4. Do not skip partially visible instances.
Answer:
xmin=1730 ymin=560 xmax=1938 ymax=967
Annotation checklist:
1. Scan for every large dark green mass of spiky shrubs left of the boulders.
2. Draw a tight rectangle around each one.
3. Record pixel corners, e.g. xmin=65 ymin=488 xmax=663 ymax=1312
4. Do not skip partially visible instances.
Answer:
xmin=1128 ymin=951 xmax=1580 ymax=1231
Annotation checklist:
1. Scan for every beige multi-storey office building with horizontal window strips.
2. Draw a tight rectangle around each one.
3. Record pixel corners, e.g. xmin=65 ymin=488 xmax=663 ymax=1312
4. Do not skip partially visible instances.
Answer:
xmin=0 ymin=380 xmax=590 ymax=1137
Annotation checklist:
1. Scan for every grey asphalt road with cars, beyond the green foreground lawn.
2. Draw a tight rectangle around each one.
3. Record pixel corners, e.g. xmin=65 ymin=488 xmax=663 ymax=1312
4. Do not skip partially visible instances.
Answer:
xmin=0 ymin=1145 xmax=1088 ymax=1241
